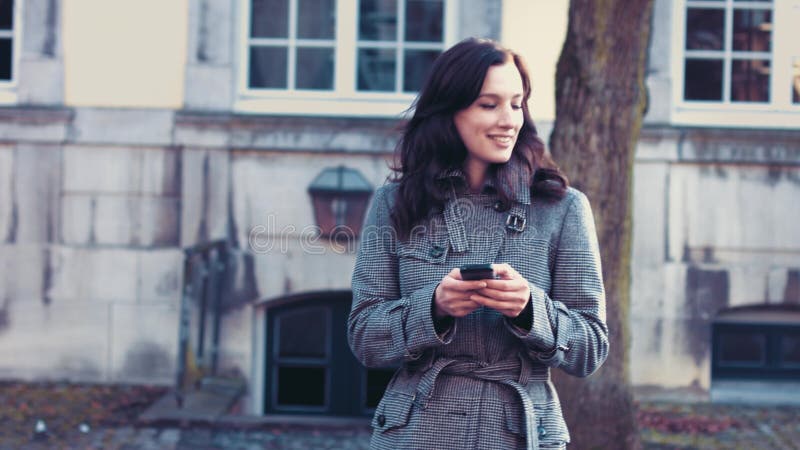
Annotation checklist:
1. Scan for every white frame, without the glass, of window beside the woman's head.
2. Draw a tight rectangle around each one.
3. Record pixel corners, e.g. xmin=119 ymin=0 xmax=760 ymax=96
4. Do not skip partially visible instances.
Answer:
xmin=233 ymin=0 xmax=459 ymax=117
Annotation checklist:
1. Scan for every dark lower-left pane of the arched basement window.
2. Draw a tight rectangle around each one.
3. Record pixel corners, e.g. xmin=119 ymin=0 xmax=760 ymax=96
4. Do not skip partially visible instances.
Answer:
xmin=278 ymin=367 xmax=325 ymax=406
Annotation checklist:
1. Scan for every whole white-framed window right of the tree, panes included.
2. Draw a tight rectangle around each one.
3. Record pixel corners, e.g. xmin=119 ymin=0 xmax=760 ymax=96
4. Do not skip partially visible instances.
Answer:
xmin=673 ymin=0 xmax=800 ymax=127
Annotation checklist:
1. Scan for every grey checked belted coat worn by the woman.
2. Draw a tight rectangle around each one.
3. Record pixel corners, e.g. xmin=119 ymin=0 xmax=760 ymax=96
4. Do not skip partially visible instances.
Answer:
xmin=348 ymin=167 xmax=609 ymax=450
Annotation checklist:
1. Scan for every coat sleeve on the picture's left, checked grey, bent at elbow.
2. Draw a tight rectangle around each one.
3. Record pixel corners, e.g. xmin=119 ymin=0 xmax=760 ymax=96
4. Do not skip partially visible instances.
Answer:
xmin=347 ymin=186 xmax=455 ymax=367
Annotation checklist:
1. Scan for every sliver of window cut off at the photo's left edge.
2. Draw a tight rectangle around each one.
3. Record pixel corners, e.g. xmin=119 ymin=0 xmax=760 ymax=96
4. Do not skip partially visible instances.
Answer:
xmin=0 ymin=0 xmax=20 ymax=104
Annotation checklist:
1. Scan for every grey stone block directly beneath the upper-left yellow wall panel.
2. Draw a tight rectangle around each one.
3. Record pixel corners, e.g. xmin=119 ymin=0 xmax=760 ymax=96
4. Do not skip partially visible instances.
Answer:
xmin=70 ymin=108 xmax=174 ymax=146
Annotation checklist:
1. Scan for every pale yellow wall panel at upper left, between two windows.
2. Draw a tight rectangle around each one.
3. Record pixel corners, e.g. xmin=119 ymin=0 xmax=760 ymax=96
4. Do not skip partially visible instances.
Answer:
xmin=62 ymin=0 xmax=189 ymax=108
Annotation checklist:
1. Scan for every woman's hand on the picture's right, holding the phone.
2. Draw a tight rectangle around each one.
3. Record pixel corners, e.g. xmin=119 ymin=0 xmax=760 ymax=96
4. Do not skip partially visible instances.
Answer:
xmin=470 ymin=264 xmax=531 ymax=318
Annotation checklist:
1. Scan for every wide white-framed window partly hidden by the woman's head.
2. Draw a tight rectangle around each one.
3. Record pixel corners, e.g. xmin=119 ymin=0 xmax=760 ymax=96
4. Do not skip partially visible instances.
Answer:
xmin=235 ymin=0 xmax=457 ymax=116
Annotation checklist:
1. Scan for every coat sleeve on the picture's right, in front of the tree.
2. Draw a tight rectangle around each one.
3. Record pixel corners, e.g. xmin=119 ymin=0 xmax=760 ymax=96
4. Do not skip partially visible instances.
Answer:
xmin=508 ymin=190 xmax=609 ymax=377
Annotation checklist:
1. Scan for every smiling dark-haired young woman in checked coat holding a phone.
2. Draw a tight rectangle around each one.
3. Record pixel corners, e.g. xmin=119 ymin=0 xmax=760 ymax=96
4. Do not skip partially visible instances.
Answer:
xmin=348 ymin=39 xmax=608 ymax=450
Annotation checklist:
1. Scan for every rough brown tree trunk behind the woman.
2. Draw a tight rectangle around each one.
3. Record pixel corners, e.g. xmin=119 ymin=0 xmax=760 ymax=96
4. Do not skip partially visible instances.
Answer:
xmin=550 ymin=0 xmax=653 ymax=450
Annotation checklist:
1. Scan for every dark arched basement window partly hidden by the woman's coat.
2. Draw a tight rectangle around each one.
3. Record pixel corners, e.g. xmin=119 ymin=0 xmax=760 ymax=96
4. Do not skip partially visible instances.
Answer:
xmin=264 ymin=292 xmax=394 ymax=416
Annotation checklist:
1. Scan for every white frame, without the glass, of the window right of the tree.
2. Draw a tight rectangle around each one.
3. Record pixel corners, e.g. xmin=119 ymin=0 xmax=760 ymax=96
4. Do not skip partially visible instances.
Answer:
xmin=671 ymin=0 xmax=800 ymax=129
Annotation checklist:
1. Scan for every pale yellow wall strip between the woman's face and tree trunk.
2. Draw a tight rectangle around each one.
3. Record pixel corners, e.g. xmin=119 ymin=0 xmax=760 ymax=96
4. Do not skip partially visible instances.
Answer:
xmin=501 ymin=0 xmax=569 ymax=121
